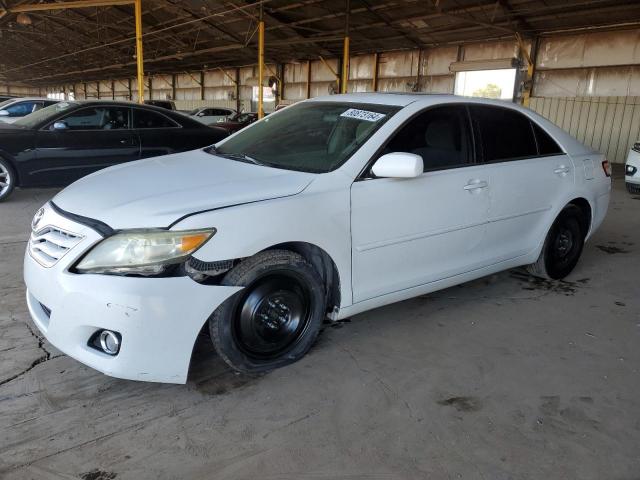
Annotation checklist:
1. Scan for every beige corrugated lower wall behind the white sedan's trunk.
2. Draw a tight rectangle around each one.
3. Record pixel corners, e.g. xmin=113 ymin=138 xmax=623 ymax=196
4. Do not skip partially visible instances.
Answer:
xmin=530 ymin=97 xmax=640 ymax=163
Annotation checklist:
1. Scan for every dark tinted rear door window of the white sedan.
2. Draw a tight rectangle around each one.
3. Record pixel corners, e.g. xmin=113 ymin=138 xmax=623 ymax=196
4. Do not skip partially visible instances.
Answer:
xmin=469 ymin=105 xmax=538 ymax=163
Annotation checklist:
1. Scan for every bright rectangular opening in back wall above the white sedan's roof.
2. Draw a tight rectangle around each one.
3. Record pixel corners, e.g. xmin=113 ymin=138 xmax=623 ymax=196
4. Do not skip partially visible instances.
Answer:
xmin=455 ymin=68 xmax=516 ymax=100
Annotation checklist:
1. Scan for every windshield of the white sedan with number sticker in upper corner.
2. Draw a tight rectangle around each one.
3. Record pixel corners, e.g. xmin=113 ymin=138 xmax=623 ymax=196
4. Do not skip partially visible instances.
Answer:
xmin=209 ymin=102 xmax=399 ymax=173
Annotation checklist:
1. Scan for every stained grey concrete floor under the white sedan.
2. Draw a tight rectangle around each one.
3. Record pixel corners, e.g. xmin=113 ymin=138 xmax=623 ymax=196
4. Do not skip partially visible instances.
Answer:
xmin=0 ymin=180 xmax=640 ymax=480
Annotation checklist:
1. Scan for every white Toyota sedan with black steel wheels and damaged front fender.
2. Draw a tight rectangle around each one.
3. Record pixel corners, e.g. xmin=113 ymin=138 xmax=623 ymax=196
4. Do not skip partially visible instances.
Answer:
xmin=24 ymin=94 xmax=611 ymax=383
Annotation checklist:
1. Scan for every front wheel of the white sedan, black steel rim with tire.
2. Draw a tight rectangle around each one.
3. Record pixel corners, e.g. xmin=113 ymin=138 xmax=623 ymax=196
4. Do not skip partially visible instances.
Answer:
xmin=209 ymin=250 xmax=326 ymax=373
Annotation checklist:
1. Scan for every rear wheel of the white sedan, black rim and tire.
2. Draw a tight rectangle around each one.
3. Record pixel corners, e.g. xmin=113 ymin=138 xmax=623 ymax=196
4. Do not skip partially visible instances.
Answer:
xmin=527 ymin=205 xmax=587 ymax=280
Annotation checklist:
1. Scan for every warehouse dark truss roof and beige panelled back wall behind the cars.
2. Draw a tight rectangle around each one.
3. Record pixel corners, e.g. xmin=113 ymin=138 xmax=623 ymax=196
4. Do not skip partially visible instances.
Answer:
xmin=0 ymin=0 xmax=640 ymax=163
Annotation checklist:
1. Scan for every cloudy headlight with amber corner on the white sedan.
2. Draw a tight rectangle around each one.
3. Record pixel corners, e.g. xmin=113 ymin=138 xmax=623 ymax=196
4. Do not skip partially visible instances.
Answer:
xmin=75 ymin=228 xmax=216 ymax=275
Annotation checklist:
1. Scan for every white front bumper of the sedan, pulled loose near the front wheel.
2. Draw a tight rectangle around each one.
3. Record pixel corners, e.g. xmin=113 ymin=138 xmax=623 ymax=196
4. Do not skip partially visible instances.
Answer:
xmin=24 ymin=207 xmax=241 ymax=383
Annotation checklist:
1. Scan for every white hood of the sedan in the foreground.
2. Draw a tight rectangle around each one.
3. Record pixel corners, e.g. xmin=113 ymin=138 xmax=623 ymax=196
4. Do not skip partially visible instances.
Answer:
xmin=53 ymin=150 xmax=315 ymax=229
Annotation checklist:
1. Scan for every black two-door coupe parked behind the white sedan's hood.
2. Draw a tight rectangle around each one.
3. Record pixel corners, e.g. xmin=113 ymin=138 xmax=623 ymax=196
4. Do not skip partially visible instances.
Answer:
xmin=0 ymin=101 xmax=227 ymax=200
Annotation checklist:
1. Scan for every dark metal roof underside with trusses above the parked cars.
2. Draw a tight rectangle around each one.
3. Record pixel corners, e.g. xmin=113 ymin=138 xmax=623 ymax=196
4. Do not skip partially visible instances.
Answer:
xmin=0 ymin=0 xmax=640 ymax=85
